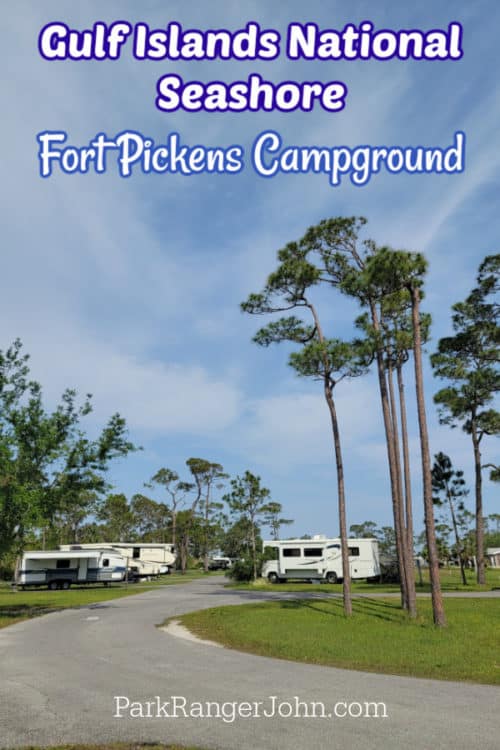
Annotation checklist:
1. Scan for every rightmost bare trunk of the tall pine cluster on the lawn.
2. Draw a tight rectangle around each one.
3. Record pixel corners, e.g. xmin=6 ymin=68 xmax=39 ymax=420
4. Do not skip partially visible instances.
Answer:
xmin=409 ymin=286 xmax=446 ymax=627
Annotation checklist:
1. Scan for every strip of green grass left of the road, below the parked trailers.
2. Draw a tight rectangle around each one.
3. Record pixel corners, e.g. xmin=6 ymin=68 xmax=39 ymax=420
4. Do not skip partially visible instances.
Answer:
xmin=0 ymin=570 xmax=219 ymax=628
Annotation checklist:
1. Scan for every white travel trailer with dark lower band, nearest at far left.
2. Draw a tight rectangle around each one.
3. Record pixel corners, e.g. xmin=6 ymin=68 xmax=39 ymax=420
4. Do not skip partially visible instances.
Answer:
xmin=14 ymin=549 xmax=127 ymax=590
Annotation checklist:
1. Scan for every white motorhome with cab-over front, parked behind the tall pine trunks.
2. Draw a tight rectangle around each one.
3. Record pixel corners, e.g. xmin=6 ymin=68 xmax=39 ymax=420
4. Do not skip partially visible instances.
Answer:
xmin=262 ymin=536 xmax=380 ymax=583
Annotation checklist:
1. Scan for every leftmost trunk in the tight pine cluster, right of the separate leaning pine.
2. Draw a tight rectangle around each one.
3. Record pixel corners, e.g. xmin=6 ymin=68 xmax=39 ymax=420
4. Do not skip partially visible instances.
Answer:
xmin=370 ymin=301 xmax=407 ymax=607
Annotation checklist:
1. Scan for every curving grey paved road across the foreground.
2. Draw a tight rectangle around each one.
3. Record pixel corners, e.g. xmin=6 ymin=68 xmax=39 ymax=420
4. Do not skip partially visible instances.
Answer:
xmin=0 ymin=577 xmax=500 ymax=750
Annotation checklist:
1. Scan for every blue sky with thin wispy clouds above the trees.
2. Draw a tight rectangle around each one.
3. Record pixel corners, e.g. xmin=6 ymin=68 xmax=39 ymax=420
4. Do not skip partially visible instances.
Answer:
xmin=0 ymin=0 xmax=500 ymax=535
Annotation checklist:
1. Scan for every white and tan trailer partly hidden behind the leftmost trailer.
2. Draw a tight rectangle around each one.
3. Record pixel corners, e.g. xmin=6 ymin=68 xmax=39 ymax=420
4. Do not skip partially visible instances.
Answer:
xmin=59 ymin=542 xmax=175 ymax=580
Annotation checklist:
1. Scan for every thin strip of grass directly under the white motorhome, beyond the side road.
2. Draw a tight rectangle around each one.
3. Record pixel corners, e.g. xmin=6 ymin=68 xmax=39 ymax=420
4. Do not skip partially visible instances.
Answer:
xmin=229 ymin=568 xmax=500 ymax=594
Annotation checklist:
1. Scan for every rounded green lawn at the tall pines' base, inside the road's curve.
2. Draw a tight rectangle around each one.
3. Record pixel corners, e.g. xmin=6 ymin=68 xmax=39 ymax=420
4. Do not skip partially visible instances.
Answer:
xmin=175 ymin=598 xmax=500 ymax=684
